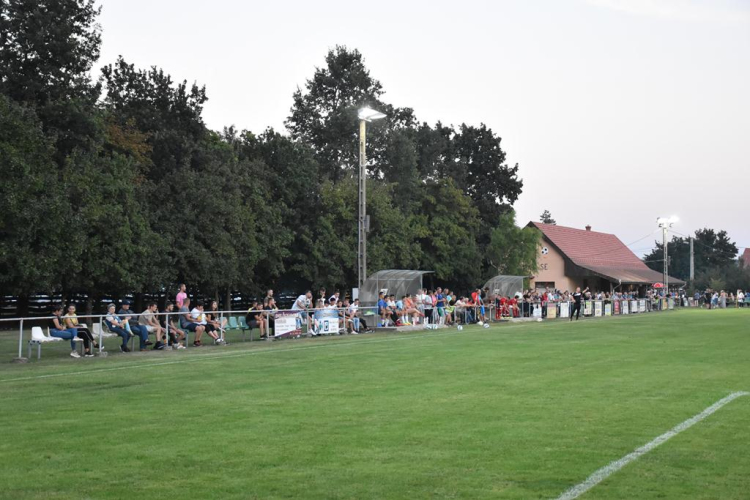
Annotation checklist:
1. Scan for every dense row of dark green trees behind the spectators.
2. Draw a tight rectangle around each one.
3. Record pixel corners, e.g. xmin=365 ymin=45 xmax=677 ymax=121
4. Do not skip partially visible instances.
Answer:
xmin=0 ymin=0 xmax=616 ymax=308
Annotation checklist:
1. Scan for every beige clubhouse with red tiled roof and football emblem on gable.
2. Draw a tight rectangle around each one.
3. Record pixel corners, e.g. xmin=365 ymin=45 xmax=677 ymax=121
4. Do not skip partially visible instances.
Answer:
xmin=527 ymin=222 xmax=685 ymax=291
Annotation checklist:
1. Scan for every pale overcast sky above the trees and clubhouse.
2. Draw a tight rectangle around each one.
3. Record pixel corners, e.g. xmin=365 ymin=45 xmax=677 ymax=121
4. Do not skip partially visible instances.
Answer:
xmin=100 ymin=0 xmax=750 ymax=255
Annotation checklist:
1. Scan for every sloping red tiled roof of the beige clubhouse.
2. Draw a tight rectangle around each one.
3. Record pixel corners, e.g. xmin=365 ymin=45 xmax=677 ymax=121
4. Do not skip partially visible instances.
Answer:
xmin=529 ymin=222 xmax=685 ymax=284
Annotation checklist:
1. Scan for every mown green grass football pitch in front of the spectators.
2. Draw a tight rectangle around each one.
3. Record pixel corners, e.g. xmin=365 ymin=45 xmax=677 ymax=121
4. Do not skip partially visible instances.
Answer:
xmin=0 ymin=309 xmax=750 ymax=499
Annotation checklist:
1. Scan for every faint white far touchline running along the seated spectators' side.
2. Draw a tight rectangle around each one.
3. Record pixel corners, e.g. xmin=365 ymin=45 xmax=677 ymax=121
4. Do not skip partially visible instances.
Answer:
xmin=0 ymin=329 xmax=470 ymax=384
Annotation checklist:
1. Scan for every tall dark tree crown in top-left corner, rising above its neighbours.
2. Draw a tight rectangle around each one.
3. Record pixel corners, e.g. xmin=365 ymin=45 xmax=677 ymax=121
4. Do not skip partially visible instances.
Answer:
xmin=0 ymin=0 xmax=101 ymax=161
